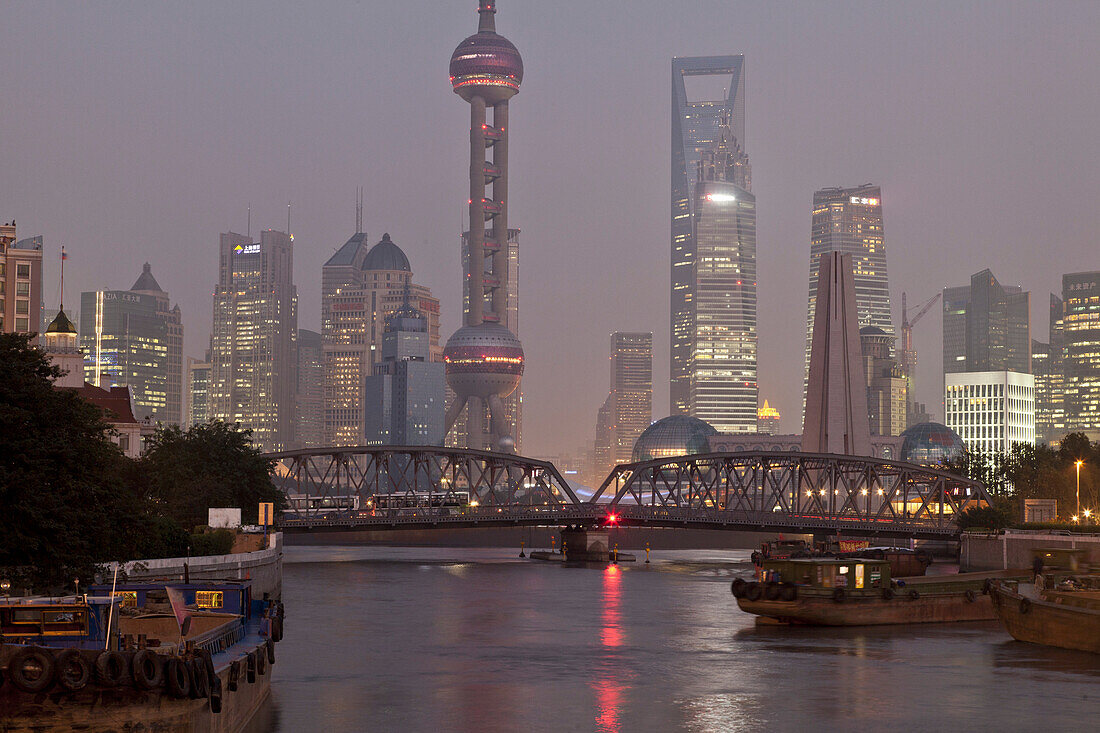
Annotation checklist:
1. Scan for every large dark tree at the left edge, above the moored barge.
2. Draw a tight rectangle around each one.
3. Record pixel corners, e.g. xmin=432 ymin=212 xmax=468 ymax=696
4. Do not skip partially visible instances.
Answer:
xmin=0 ymin=333 xmax=145 ymax=589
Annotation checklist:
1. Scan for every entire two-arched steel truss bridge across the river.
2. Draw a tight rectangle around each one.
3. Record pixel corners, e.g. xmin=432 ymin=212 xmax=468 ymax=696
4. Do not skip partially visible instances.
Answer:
xmin=267 ymin=446 xmax=989 ymax=538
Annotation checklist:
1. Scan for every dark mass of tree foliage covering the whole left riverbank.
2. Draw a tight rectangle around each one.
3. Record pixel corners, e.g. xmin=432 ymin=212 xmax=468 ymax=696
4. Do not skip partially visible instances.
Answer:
xmin=0 ymin=333 xmax=284 ymax=591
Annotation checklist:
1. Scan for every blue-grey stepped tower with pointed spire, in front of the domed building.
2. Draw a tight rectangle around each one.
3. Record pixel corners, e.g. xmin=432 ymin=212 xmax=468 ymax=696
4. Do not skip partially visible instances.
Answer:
xmin=363 ymin=297 xmax=446 ymax=446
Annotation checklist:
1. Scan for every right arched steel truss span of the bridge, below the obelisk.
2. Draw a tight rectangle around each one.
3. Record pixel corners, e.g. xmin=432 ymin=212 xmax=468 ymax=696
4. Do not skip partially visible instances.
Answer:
xmin=591 ymin=451 xmax=990 ymax=527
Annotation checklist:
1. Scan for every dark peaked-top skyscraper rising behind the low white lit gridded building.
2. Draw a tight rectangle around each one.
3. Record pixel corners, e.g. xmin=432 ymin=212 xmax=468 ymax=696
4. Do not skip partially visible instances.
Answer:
xmin=944 ymin=270 xmax=1031 ymax=374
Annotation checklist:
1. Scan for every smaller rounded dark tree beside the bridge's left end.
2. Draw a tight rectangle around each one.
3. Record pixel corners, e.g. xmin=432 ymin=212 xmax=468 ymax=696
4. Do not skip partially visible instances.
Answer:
xmin=138 ymin=420 xmax=286 ymax=527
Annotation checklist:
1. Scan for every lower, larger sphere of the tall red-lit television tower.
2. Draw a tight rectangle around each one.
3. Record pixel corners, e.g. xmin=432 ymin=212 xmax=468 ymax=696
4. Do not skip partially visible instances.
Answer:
xmin=443 ymin=324 xmax=524 ymax=400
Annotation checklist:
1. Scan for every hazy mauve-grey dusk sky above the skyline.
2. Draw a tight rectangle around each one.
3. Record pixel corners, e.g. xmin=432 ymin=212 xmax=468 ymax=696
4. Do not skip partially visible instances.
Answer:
xmin=0 ymin=0 xmax=1100 ymax=455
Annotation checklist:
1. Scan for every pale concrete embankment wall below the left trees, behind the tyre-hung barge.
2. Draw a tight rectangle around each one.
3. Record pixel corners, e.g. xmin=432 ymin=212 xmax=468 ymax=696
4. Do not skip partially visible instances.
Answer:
xmin=105 ymin=533 xmax=283 ymax=599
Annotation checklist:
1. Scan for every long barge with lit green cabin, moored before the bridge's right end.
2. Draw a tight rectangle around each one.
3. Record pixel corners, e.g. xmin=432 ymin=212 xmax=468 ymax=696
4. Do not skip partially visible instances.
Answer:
xmin=730 ymin=558 xmax=1030 ymax=626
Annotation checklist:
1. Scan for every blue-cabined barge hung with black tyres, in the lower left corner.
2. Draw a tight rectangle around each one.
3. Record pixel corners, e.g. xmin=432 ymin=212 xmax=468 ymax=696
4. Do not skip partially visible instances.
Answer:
xmin=0 ymin=580 xmax=284 ymax=733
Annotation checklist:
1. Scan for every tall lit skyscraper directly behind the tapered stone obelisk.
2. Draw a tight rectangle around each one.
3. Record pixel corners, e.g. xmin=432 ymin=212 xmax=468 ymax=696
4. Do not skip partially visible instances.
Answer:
xmin=806 ymin=184 xmax=894 ymax=405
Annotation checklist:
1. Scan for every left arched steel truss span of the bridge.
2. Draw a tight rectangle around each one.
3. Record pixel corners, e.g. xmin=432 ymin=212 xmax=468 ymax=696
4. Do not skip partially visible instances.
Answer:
xmin=266 ymin=446 xmax=581 ymax=515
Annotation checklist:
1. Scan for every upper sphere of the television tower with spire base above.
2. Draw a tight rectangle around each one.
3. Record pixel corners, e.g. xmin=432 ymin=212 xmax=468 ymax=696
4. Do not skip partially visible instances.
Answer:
xmin=451 ymin=0 xmax=524 ymax=103
